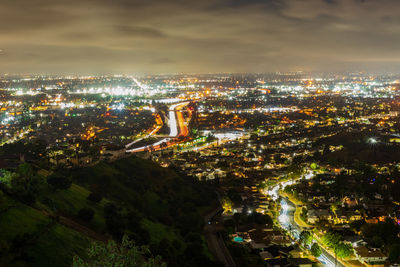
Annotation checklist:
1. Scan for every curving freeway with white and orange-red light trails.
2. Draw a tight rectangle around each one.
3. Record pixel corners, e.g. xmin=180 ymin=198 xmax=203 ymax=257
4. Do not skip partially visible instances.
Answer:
xmin=126 ymin=102 xmax=189 ymax=153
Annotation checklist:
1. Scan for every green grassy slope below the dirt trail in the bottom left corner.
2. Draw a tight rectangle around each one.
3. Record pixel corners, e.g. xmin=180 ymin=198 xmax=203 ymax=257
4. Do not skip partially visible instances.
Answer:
xmin=0 ymin=195 xmax=89 ymax=267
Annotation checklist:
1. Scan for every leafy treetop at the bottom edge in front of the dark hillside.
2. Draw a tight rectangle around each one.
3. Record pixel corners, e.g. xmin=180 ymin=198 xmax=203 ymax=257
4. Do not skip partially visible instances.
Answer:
xmin=72 ymin=235 xmax=166 ymax=267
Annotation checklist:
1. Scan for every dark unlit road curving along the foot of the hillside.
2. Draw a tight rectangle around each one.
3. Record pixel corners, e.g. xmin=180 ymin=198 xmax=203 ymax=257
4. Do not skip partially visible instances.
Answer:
xmin=204 ymin=206 xmax=236 ymax=267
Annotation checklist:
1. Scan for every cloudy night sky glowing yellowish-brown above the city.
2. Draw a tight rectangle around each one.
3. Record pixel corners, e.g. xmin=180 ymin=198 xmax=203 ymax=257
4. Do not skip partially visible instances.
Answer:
xmin=0 ymin=0 xmax=400 ymax=74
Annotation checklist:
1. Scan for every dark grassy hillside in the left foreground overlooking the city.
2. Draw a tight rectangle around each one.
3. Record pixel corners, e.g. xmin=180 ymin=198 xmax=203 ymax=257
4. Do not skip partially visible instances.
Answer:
xmin=0 ymin=157 xmax=218 ymax=266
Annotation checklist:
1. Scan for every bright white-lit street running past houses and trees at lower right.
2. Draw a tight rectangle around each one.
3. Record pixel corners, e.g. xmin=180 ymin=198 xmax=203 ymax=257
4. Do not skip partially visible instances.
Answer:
xmin=278 ymin=198 xmax=344 ymax=267
